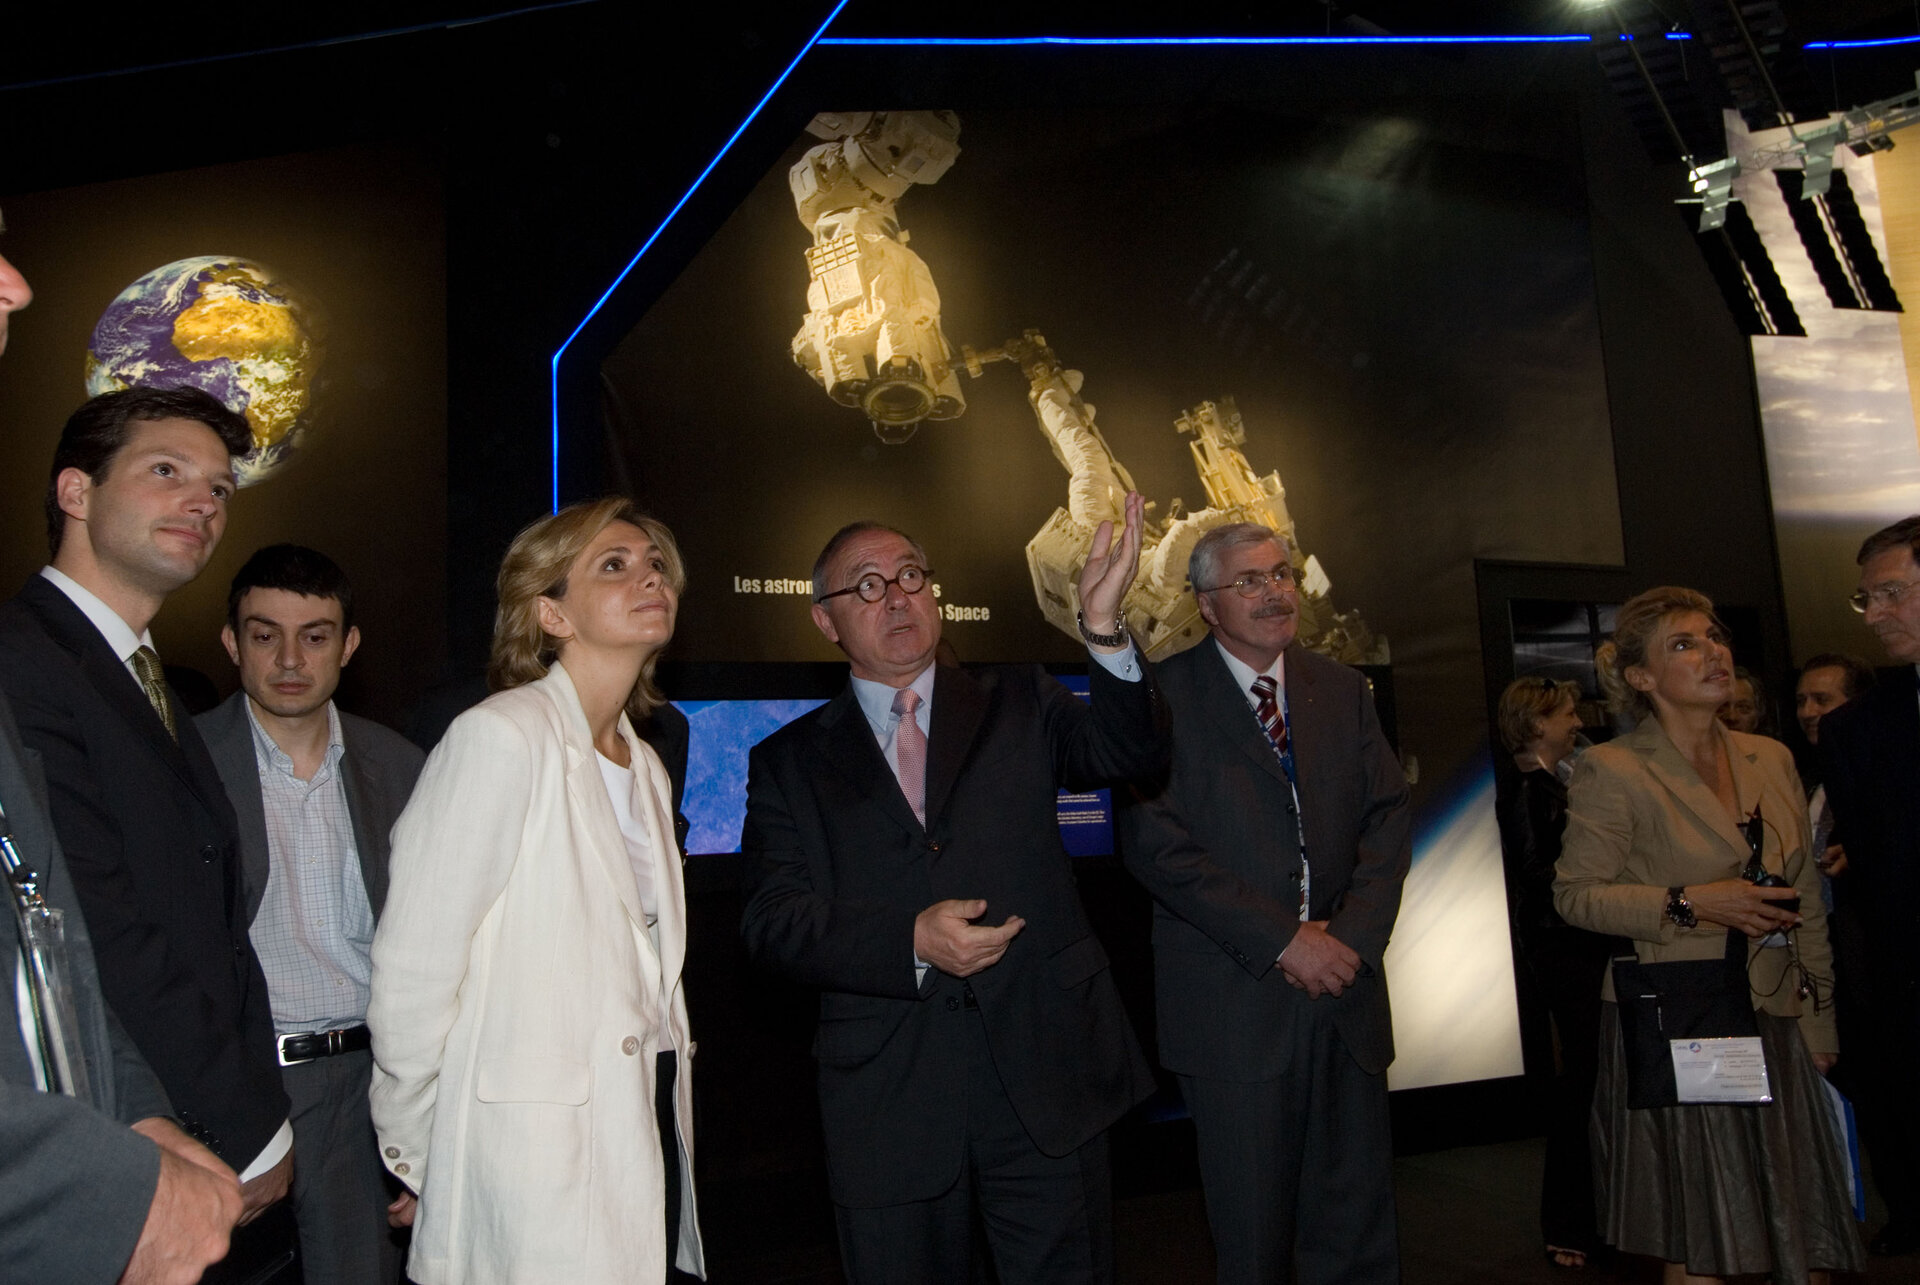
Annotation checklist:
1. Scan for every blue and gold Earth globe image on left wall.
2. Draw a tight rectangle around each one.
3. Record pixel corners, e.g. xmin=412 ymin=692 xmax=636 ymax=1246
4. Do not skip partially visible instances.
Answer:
xmin=86 ymin=254 xmax=321 ymax=486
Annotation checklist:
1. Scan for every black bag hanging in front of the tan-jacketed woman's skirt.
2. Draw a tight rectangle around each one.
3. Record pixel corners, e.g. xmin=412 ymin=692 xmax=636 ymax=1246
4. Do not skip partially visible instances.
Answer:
xmin=1613 ymin=930 xmax=1761 ymax=1110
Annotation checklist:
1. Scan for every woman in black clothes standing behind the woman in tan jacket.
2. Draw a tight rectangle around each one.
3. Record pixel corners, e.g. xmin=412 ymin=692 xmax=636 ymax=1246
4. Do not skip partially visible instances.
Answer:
xmin=1498 ymin=678 xmax=1607 ymax=1268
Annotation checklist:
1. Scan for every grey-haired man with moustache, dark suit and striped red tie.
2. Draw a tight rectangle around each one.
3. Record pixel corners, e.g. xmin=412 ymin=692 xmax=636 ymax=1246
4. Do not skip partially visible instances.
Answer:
xmin=1117 ymin=522 xmax=1411 ymax=1285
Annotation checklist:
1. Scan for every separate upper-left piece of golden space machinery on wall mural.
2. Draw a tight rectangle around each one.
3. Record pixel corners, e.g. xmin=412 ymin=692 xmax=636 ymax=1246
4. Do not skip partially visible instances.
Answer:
xmin=787 ymin=111 xmax=966 ymax=446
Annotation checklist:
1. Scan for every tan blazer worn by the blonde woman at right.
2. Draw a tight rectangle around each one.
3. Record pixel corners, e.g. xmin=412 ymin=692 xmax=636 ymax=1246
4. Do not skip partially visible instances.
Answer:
xmin=1553 ymin=718 xmax=1839 ymax=1053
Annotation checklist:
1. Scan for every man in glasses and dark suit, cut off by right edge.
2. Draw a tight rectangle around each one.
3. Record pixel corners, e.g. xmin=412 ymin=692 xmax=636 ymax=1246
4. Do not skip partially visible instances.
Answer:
xmin=1818 ymin=515 xmax=1920 ymax=1254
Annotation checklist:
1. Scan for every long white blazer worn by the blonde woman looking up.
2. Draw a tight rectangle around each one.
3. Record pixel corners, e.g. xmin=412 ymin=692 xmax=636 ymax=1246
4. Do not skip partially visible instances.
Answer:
xmin=367 ymin=665 xmax=705 ymax=1285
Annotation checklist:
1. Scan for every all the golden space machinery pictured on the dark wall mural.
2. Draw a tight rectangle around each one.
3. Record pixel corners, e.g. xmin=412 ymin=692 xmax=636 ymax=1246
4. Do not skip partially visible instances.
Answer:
xmin=787 ymin=111 xmax=1388 ymax=665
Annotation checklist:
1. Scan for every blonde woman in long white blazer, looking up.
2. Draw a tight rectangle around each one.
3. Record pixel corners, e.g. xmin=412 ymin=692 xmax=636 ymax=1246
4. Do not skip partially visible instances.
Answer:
xmin=367 ymin=497 xmax=705 ymax=1285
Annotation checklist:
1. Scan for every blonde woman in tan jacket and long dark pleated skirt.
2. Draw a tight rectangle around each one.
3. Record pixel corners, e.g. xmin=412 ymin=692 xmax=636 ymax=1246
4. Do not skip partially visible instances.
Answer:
xmin=1553 ymin=588 xmax=1864 ymax=1283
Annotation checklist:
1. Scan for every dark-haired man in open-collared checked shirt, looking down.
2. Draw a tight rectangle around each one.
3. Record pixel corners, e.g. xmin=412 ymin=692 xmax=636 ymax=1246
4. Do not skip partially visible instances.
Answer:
xmin=196 ymin=544 xmax=426 ymax=1285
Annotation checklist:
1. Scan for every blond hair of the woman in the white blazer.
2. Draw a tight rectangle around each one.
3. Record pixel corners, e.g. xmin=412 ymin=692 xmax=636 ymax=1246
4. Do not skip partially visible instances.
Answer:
xmin=486 ymin=496 xmax=687 ymax=722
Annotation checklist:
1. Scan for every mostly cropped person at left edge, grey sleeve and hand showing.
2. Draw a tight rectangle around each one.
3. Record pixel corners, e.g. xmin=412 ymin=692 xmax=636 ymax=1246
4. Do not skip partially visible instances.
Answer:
xmin=0 ymin=215 xmax=242 ymax=1285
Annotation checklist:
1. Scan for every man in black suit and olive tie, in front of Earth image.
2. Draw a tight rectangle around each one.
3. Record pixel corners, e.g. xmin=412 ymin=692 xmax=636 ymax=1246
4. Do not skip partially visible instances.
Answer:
xmin=0 ymin=388 xmax=292 ymax=1216
